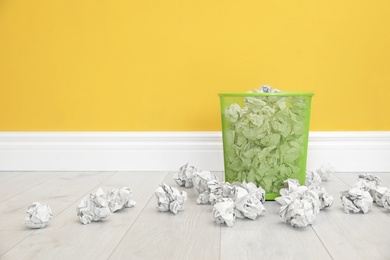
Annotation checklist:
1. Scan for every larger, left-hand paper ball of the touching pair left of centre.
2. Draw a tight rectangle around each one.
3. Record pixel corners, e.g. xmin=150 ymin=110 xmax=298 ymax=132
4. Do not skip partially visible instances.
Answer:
xmin=76 ymin=188 xmax=111 ymax=224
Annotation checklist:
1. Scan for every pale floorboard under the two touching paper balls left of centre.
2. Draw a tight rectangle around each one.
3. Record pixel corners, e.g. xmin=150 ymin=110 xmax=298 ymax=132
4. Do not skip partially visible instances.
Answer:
xmin=3 ymin=172 xmax=166 ymax=259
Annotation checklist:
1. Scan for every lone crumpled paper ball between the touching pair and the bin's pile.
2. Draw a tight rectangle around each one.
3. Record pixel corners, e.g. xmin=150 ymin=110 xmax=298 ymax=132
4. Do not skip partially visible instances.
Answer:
xmin=154 ymin=183 xmax=187 ymax=214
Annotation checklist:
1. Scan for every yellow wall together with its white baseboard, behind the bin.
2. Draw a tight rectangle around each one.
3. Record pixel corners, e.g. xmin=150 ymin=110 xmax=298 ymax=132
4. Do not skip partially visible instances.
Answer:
xmin=0 ymin=0 xmax=390 ymax=174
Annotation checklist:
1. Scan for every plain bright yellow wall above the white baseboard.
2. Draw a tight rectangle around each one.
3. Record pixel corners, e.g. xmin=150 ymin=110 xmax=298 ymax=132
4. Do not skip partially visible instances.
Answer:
xmin=0 ymin=0 xmax=390 ymax=131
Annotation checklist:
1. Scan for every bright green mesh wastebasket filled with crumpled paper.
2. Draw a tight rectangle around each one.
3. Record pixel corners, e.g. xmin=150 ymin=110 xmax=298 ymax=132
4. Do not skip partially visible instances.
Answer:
xmin=219 ymin=92 xmax=313 ymax=200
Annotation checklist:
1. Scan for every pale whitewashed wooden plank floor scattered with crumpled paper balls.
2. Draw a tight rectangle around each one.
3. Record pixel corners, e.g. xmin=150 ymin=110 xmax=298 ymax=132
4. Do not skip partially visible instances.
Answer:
xmin=0 ymin=172 xmax=390 ymax=259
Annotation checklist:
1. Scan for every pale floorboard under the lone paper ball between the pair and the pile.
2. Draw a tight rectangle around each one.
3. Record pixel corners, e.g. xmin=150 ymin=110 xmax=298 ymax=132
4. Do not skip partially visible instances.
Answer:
xmin=111 ymin=173 xmax=222 ymax=259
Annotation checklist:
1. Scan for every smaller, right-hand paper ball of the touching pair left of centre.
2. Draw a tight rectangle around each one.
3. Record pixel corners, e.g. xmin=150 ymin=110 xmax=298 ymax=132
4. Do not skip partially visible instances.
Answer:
xmin=107 ymin=187 xmax=136 ymax=212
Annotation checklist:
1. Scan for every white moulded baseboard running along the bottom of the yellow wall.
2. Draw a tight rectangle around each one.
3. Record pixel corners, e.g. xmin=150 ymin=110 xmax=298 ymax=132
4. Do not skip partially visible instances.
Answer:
xmin=0 ymin=131 xmax=390 ymax=172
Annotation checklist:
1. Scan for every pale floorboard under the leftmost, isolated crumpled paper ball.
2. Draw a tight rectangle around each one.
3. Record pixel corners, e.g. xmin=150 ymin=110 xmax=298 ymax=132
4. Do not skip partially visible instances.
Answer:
xmin=0 ymin=172 xmax=113 ymax=255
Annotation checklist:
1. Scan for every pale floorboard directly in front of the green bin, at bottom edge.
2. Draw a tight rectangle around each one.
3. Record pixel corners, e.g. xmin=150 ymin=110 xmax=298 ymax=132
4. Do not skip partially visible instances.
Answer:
xmin=221 ymin=201 xmax=331 ymax=259
